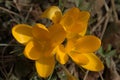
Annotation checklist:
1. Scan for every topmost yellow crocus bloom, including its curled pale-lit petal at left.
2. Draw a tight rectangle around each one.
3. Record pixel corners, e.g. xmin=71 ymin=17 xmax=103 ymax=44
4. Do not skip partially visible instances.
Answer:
xmin=41 ymin=6 xmax=90 ymax=38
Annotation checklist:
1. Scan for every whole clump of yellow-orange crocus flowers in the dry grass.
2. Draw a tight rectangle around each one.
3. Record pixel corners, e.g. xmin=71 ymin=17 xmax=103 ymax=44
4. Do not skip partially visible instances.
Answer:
xmin=12 ymin=6 xmax=104 ymax=78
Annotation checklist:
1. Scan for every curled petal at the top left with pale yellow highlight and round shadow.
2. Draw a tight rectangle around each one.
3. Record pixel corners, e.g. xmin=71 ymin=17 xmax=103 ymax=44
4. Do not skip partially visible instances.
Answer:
xmin=41 ymin=6 xmax=62 ymax=23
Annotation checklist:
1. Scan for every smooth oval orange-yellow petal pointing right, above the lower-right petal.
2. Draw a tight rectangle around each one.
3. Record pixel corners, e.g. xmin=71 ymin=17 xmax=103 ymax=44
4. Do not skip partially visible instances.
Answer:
xmin=75 ymin=35 xmax=101 ymax=52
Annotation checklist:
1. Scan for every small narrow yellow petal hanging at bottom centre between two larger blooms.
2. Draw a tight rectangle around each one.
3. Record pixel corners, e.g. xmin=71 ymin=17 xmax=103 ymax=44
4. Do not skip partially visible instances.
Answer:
xmin=56 ymin=45 xmax=69 ymax=64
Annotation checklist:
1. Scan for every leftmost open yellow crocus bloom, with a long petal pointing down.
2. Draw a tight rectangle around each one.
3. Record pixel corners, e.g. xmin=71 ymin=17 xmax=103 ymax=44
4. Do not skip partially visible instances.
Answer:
xmin=12 ymin=24 xmax=66 ymax=78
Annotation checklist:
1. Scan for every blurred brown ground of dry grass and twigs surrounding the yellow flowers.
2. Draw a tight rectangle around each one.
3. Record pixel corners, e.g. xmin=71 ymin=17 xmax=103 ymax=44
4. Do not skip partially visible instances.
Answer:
xmin=0 ymin=0 xmax=120 ymax=80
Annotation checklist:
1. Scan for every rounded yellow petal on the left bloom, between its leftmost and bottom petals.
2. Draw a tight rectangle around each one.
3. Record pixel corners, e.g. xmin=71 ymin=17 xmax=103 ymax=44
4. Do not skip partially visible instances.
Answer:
xmin=24 ymin=41 xmax=41 ymax=60
